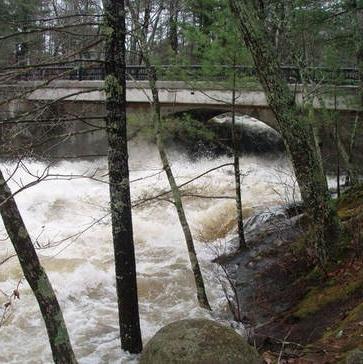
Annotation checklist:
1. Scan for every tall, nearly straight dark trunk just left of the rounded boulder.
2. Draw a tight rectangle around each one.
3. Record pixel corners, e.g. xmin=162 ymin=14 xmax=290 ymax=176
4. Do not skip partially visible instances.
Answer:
xmin=104 ymin=0 xmax=142 ymax=353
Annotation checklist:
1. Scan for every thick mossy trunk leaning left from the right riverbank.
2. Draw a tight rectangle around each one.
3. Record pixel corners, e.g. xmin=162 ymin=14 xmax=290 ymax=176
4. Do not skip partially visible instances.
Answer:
xmin=229 ymin=0 xmax=341 ymax=266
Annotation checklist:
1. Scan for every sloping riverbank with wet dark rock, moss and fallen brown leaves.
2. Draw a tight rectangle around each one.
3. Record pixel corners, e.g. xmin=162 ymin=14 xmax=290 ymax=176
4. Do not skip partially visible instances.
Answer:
xmin=225 ymin=185 xmax=363 ymax=363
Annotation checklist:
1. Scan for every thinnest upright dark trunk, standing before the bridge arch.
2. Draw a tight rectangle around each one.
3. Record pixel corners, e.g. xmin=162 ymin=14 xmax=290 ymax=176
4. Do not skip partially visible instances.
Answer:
xmin=232 ymin=62 xmax=247 ymax=250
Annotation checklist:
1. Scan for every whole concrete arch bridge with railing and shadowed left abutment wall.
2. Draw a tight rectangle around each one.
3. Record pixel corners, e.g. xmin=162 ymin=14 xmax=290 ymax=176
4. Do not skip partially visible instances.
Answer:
xmin=0 ymin=66 xmax=363 ymax=156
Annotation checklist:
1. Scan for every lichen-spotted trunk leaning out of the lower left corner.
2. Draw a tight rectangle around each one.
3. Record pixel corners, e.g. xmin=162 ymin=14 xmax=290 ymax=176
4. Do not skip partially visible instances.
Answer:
xmin=0 ymin=171 xmax=77 ymax=364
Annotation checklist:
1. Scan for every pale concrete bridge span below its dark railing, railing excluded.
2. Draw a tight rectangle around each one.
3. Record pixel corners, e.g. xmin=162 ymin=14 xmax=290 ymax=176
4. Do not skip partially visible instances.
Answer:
xmin=0 ymin=80 xmax=359 ymax=127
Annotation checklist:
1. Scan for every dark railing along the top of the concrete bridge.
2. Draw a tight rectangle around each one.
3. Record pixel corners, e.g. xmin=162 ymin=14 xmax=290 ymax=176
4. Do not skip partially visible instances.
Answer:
xmin=7 ymin=65 xmax=359 ymax=84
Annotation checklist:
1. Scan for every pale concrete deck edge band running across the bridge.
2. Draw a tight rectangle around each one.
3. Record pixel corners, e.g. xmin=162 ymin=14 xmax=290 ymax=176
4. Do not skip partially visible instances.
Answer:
xmin=0 ymin=80 xmax=360 ymax=111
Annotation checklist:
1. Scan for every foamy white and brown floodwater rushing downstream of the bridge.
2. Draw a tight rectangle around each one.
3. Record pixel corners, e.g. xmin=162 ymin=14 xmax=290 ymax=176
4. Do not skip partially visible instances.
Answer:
xmin=0 ymin=142 xmax=293 ymax=363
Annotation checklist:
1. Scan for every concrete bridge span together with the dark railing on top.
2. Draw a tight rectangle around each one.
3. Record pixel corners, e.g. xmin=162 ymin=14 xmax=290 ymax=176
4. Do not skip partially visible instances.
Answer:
xmin=0 ymin=63 xmax=359 ymax=126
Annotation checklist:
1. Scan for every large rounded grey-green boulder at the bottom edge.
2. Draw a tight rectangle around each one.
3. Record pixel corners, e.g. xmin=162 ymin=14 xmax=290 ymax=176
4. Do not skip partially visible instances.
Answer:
xmin=140 ymin=319 xmax=262 ymax=364
